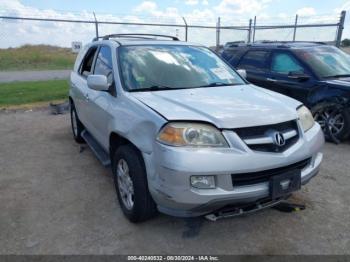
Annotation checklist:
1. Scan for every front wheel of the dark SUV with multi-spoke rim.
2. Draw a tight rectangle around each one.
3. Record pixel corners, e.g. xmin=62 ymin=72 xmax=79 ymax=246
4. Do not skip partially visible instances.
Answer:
xmin=311 ymin=102 xmax=350 ymax=141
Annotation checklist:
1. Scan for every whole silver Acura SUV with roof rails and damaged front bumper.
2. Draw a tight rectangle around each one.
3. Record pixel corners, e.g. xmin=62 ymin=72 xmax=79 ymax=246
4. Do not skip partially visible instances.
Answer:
xmin=69 ymin=34 xmax=324 ymax=222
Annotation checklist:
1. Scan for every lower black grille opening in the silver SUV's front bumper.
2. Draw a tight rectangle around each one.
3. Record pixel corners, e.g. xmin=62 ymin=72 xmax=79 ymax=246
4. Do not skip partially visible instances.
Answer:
xmin=231 ymin=158 xmax=311 ymax=186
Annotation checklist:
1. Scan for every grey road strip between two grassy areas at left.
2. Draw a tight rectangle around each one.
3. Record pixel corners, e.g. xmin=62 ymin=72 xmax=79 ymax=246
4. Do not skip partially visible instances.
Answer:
xmin=0 ymin=70 xmax=71 ymax=83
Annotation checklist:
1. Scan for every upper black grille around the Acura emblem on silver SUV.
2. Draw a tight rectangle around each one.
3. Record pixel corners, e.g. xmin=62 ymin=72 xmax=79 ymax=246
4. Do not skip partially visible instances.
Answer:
xmin=234 ymin=120 xmax=299 ymax=153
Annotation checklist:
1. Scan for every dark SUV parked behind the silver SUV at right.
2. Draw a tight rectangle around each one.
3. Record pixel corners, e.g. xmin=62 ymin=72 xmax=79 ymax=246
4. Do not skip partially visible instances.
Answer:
xmin=222 ymin=42 xmax=350 ymax=140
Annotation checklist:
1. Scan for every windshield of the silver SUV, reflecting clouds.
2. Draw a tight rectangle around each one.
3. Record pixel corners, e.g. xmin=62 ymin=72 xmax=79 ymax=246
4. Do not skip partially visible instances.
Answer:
xmin=119 ymin=45 xmax=245 ymax=91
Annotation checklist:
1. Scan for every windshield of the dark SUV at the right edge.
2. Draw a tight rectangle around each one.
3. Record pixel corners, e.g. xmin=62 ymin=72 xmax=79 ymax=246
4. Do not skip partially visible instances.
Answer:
xmin=295 ymin=46 xmax=350 ymax=78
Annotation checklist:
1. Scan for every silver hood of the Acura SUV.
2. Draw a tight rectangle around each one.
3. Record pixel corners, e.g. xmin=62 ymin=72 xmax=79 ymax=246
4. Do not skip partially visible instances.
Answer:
xmin=130 ymin=85 xmax=301 ymax=128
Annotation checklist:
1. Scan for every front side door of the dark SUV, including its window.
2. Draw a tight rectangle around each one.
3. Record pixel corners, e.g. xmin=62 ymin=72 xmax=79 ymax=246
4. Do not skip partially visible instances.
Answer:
xmin=268 ymin=50 xmax=316 ymax=103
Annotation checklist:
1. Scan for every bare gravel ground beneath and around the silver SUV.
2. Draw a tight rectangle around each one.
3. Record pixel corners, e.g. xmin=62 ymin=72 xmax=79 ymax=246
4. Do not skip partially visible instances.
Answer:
xmin=0 ymin=110 xmax=350 ymax=254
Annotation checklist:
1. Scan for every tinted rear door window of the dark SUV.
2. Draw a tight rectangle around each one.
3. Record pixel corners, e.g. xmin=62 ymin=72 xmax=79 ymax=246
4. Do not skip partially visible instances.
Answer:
xmin=238 ymin=50 xmax=269 ymax=71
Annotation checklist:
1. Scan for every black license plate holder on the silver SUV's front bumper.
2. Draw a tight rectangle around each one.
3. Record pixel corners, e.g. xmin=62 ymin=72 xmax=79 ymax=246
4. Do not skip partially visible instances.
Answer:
xmin=270 ymin=170 xmax=301 ymax=199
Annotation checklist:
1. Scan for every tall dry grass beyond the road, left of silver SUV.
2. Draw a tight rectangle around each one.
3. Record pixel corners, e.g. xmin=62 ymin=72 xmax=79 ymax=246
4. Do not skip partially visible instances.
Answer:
xmin=0 ymin=45 xmax=76 ymax=71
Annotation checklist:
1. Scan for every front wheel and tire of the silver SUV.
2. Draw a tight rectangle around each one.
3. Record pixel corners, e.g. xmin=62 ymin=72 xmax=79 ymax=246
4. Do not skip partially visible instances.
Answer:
xmin=112 ymin=144 xmax=157 ymax=223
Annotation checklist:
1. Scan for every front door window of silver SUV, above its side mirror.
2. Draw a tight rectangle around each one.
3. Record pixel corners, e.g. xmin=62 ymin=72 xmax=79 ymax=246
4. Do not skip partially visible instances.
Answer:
xmin=94 ymin=46 xmax=113 ymax=84
